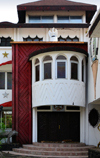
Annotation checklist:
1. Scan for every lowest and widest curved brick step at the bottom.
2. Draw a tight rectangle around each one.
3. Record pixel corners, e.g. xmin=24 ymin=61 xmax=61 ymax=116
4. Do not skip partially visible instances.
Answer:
xmin=3 ymin=151 xmax=88 ymax=158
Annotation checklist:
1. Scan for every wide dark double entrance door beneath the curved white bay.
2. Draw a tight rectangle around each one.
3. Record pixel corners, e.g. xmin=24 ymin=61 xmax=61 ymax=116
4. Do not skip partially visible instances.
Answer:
xmin=37 ymin=112 xmax=80 ymax=142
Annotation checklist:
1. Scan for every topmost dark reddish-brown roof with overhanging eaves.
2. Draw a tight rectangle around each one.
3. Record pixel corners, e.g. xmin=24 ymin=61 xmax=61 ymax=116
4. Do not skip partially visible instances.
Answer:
xmin=17 ymin=0 xmax=97 ymax=23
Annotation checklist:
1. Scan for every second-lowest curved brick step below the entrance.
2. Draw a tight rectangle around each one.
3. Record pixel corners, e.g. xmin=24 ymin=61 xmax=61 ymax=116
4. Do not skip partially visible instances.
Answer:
xmin=13 ymin=148 xmax=88 ymax=156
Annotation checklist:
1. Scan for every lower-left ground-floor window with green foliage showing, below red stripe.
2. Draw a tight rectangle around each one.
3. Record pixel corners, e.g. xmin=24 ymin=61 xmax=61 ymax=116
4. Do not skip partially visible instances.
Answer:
xmin=0 ymin=111 xmax=12 ymax=128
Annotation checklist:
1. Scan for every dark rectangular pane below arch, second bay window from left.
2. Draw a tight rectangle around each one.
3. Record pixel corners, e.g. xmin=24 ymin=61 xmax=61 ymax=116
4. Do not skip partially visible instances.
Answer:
xmin=44 ymin=63 xmax=51 ymax=79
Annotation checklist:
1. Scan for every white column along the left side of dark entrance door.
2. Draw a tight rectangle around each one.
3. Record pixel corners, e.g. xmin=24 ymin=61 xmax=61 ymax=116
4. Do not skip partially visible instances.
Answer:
xmin=32 ymin=108 xmax=37 ymax=143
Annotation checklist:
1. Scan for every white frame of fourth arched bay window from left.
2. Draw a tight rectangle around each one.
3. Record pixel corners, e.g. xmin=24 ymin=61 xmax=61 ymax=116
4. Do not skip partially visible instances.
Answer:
xmin=70 ymin=55 xmax=79 ymax=80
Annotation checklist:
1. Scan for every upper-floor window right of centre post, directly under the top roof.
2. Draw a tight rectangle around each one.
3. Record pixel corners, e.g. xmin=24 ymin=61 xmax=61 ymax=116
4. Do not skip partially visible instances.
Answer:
xmin=57 ymin=16 xmax=82 ymax=23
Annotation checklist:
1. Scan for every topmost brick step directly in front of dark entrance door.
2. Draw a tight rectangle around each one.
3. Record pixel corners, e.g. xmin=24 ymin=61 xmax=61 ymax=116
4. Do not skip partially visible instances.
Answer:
xmin=33 ymin=143 xmax=85 ymax=147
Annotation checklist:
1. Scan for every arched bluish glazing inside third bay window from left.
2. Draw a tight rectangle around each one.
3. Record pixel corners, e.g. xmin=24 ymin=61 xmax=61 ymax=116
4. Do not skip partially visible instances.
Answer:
xmin=56 ymin=55 xmax=67 ymax=78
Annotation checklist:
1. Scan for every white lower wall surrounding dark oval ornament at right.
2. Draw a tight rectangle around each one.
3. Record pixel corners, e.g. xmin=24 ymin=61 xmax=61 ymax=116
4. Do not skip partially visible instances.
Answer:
xmin=88 ymin=104 xmax=100 ymax=146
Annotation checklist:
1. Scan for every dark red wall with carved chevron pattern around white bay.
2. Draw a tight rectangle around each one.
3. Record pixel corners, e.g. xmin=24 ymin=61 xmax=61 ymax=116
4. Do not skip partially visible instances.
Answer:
xmin=12 ymin=42 xmax=87 ymax=144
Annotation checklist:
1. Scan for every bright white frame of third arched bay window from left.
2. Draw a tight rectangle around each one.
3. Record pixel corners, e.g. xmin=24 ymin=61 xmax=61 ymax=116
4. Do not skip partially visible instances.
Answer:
xmin=56 ymin=55 xmax=67 ymax=79
